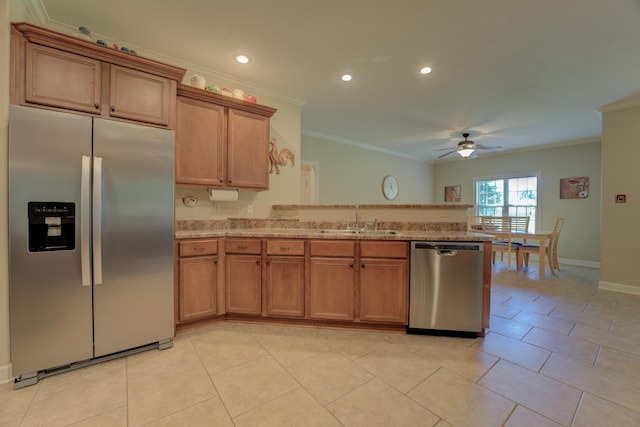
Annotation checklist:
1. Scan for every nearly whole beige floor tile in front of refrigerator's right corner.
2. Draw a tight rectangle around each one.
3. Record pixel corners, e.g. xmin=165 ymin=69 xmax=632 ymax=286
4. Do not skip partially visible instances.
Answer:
xmin=128 ymin=361 xmax=216 ymax=426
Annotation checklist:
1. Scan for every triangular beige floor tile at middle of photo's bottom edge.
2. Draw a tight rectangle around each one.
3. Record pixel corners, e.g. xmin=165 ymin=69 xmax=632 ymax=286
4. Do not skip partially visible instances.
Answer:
xmin=234 ymin=388 xmax=341 ymax=427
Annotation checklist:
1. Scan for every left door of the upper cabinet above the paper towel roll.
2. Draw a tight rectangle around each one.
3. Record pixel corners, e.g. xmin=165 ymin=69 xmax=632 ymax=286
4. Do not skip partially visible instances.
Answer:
xmin=175 ymin=97 xmax=225 ymax=187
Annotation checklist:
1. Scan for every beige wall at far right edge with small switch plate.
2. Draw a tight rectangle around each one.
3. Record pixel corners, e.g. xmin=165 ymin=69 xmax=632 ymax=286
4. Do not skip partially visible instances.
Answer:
xmin=600 ymin=103 xmax=640 ymax=294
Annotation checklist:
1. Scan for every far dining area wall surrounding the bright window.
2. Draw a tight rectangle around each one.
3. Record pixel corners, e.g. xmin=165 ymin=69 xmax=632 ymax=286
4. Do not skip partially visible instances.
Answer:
xmin=434 ymin=142 xmax=601 ymax=266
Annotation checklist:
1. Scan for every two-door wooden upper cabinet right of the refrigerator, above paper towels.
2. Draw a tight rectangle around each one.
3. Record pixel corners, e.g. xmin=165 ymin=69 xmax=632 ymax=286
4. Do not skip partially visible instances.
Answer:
xmin=176 ymin=85 xmax=276 ymax=190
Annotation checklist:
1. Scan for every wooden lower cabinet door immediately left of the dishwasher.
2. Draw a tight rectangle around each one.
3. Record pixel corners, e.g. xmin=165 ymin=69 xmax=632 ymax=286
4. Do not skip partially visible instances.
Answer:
xmin=360 ymin=258 xmax=408 ymax=324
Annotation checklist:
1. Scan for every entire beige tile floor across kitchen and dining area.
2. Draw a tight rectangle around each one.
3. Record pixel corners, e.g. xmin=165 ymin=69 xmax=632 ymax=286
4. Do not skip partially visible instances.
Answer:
xmin=0 ymin=263 xmax=640 ymax=427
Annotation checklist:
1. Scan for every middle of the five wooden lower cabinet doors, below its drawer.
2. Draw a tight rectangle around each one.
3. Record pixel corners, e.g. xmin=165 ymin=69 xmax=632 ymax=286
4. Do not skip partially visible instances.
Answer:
xmin=266 ymin=256 xmax=304 ymax=317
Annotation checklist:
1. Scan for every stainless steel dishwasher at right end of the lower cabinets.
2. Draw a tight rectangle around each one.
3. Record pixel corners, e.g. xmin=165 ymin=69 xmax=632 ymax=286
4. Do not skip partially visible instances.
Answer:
xmin=407 ymin=242 xmax=483 ymax=336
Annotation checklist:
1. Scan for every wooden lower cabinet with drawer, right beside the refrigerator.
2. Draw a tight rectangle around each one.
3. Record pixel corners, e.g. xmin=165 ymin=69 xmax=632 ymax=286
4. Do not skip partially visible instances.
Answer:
xmin=178 ymin=239 xmax=218 ymax=322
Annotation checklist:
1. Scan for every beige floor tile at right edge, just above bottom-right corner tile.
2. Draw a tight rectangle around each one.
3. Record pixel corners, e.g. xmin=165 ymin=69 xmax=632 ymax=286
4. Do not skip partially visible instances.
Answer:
xmin=542 ymin=353 xmax=640 ymax=412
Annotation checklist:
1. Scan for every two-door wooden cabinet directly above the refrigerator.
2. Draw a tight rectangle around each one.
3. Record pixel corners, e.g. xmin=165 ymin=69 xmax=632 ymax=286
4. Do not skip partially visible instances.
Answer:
xmin=10 ymin=23 xmax=186 ymax=128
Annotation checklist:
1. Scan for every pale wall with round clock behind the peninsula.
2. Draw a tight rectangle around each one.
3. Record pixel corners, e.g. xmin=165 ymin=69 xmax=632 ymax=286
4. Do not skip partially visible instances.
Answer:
xmin=302 ymin=135 xmax=433 ymax=204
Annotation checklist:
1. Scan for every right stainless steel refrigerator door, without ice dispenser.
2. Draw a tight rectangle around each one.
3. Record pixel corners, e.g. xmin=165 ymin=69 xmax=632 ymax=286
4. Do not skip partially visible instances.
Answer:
xmin=93 ymin=119 xmax=174 ymax=357
